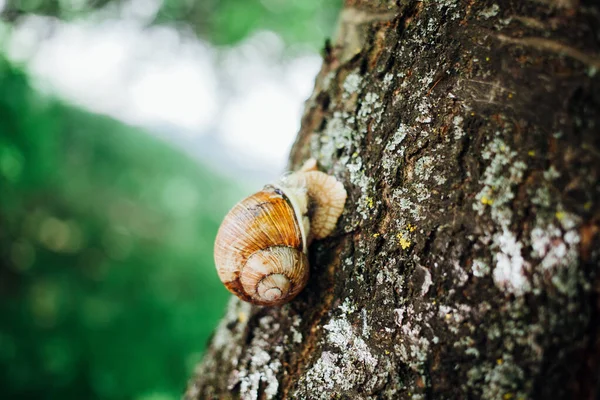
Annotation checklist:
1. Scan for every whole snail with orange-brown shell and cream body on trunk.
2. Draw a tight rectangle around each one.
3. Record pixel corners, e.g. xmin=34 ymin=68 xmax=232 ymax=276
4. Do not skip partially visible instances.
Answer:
xmin=214 ymin=159 xmax=346 ymax=305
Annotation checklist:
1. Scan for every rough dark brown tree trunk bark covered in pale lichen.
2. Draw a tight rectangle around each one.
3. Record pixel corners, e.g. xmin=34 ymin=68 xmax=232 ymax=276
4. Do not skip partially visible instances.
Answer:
xmin=186 ymin=0 xmax=600 ymax=399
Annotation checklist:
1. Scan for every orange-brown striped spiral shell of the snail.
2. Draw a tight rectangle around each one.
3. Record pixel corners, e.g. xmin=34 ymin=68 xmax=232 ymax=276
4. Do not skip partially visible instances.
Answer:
xmin=215 ymin=187 xmax=309 ymax=305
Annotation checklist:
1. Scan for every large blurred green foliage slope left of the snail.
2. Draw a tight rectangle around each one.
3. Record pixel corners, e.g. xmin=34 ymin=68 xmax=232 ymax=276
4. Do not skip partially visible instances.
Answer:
xmin=0 ymin=57 xmax=238 ymax=400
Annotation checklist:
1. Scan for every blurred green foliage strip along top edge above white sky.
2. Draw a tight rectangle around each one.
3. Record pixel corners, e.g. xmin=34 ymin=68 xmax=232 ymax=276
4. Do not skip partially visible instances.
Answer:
xmin=1 ymin=0 xmax=342 ymax=49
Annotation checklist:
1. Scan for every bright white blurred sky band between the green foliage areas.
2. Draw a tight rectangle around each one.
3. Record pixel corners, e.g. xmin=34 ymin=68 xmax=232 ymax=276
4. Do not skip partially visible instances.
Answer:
xmin=0 ymin=0 xmax=321 ymax=181
